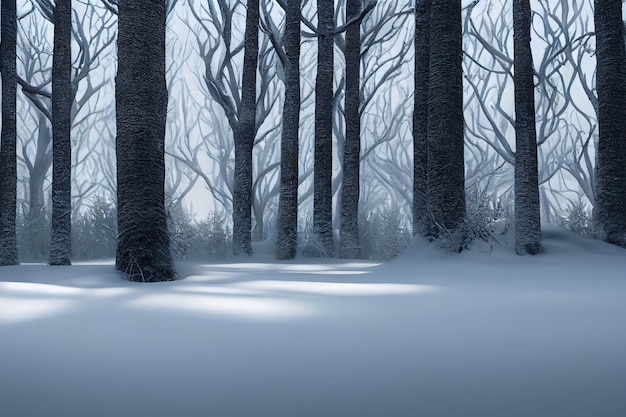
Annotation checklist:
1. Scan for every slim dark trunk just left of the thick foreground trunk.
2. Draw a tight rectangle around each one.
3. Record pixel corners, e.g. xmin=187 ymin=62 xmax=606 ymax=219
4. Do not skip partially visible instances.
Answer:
xmin=48 ymin=0 xmax=72 ymax=265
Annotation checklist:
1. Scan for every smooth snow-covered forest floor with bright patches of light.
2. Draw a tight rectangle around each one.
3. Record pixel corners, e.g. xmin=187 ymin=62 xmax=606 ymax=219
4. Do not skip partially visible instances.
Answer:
xmin=0 ymin=228 xmax=626 ymax=417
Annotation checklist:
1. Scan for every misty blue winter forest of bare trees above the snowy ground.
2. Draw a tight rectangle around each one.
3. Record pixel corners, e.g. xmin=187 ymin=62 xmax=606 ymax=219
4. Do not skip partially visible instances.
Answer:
xmin=1 ymin=0 xmax=626 ymax=272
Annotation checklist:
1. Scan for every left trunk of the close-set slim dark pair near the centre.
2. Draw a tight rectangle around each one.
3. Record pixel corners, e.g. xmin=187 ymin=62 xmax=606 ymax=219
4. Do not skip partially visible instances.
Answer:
xmin=313 ymin=0 xmax=335 ymax=257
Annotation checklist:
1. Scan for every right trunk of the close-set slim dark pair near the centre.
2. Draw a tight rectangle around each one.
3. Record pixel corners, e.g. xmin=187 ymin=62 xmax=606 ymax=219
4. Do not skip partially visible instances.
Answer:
xmin=339 ymin=0 xmax=362 ymax=258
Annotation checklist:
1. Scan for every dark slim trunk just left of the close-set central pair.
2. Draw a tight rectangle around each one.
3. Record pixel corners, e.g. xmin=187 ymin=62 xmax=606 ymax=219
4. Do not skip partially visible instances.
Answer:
xmin=276 ymin=0 xmax=301 ymax=259
